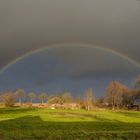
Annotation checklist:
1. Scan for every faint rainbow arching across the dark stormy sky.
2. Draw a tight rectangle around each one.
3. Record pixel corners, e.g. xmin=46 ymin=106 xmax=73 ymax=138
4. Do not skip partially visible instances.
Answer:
xmin=0 ymin=43 xmax=140 ymax=74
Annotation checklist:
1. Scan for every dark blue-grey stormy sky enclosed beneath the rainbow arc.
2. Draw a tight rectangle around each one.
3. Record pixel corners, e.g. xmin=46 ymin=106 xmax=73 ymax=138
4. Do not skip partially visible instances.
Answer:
xmin=0 ymin=46 xmax=139 ymax=95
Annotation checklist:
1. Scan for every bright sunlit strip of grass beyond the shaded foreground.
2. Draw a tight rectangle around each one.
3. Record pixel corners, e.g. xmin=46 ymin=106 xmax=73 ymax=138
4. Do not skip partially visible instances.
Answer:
xmin=0 ymin=108 xmax=140 ymax=123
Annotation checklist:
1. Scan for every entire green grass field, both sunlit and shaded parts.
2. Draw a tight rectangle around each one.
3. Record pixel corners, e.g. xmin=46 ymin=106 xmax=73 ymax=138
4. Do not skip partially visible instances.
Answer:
xmin=0 ymin=108 xmax=140 ymax=140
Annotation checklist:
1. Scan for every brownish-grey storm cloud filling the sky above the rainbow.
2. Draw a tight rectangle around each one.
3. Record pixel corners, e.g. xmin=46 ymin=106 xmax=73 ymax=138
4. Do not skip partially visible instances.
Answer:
xmin=0 ymin=0 xmax=140 ymax=67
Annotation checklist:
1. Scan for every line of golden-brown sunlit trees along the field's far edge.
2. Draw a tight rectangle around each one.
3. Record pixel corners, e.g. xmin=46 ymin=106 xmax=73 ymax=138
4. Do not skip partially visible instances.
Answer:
xmin=0 ymin=76 xmax=140 ymax=110
